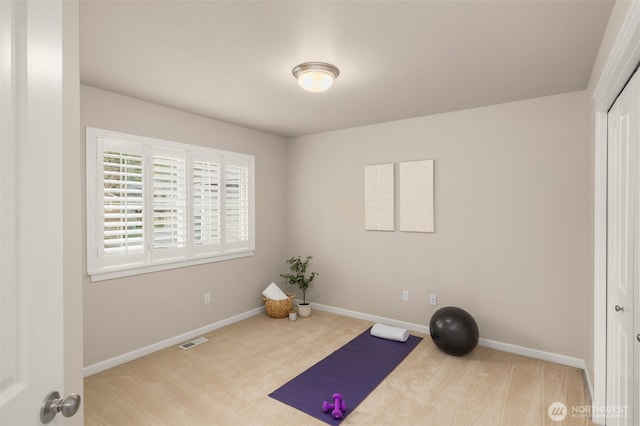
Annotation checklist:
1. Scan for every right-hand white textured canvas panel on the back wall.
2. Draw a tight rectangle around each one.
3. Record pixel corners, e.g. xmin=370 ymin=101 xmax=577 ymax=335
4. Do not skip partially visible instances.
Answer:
xmin=400 ymin=160 xmax=434 ymax=232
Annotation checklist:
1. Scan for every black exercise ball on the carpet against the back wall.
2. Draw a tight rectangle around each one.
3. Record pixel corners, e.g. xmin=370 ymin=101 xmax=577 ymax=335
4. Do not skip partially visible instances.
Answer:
xmin=429 ymin=306 xmax=480 ymax=356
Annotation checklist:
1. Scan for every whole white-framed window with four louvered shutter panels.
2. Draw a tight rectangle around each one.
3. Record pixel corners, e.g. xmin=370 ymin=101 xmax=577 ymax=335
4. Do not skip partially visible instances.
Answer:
xmin=87 ymin=128 xmax=255 ymax=281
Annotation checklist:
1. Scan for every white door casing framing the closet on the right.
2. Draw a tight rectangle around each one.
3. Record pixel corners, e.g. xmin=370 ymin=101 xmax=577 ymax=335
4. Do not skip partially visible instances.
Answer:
xmin=592 ymin=1 xmax=640 ymax=424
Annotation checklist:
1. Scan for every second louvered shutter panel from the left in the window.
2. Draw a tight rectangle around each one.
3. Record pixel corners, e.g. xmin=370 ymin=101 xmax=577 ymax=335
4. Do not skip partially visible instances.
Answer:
xmin=151 ymin=148 xmax=187 ymax=260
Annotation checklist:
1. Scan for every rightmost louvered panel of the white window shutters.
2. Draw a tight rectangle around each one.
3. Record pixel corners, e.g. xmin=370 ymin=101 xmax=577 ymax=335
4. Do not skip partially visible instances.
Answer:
xmin=224 ymin=159 xmax=250 ymax=249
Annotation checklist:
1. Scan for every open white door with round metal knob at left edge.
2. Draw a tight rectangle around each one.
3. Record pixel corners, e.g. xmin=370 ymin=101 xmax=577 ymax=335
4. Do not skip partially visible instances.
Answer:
xmin=0 ymin=0 xmax=81 ymax=426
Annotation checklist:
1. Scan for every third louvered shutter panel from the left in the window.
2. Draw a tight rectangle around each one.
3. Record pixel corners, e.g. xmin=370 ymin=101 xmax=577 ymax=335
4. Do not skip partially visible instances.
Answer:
xmin=191 ymin=154 xmax=221 ymax=253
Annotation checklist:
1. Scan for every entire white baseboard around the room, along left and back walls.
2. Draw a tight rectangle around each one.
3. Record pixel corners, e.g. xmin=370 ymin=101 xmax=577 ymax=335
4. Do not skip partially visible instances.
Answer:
xmin=84 ymin=303 xmax=593 ymax=395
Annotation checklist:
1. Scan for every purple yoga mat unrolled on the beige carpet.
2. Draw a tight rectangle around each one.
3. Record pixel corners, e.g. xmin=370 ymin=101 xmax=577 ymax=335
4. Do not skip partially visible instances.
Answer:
xmin=269 ymin=328 xmax=422 ymax=425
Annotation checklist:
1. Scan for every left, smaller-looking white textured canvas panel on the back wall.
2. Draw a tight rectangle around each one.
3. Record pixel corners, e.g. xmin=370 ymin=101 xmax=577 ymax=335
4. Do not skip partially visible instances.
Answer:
xmin=364 ymin=164 xmax=395 ymax=231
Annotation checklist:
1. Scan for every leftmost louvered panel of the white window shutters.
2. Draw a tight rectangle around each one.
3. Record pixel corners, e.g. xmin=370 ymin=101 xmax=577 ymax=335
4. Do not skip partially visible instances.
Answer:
xmin=98 ymin=138 xmax=144 ymax=266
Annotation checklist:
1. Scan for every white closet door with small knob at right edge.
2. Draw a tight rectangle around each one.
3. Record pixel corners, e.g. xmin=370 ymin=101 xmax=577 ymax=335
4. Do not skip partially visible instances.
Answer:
xmin=606 ymin=68 xmax=640 ymax=426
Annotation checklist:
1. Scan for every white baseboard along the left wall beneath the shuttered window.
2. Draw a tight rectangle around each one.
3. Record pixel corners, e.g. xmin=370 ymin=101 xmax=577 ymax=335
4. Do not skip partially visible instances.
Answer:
xmin=83 ymin=306 xmax=264 ymax=377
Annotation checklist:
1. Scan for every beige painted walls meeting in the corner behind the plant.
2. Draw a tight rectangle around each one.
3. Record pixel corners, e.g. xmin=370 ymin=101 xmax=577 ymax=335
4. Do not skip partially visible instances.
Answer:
xmin=81 ymin=73 xmax=593 ymax=366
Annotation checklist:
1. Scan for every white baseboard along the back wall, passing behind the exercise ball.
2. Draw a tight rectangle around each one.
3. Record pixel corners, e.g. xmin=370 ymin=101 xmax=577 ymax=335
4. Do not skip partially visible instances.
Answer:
xmin=313 ymin=303 xmax=593 ymax=397
